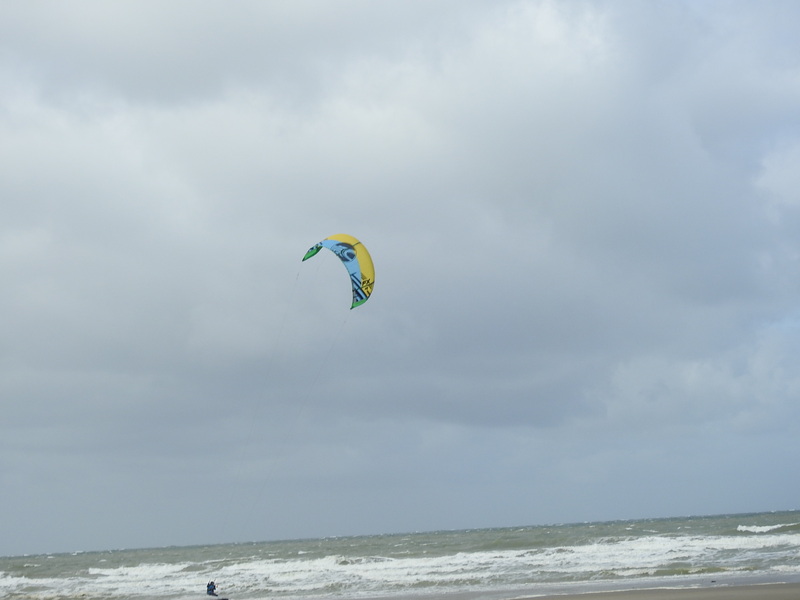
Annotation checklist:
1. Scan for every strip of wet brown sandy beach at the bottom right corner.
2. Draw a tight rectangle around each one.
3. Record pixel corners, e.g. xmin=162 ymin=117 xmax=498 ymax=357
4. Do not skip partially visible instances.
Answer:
xmin=528 ymin=583 xmax=800 ymax=600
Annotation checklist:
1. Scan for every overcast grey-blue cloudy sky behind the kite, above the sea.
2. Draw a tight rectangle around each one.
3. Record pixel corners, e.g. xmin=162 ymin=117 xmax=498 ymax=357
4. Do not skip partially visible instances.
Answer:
xmin=0 ymin=0 xmax=800 ymax=555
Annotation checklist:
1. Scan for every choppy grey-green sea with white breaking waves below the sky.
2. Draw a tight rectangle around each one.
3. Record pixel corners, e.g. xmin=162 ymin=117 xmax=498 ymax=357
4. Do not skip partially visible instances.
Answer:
xmin=0 ymin=511 xmax=800 ymax=600
